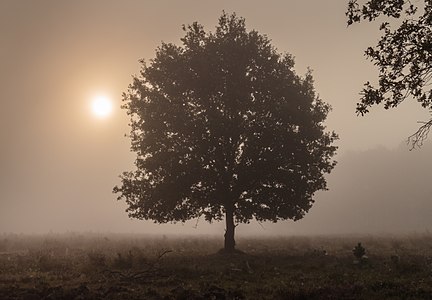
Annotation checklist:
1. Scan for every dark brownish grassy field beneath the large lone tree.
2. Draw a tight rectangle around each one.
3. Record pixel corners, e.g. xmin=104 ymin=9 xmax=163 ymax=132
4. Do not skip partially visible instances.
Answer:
xmin=0 ymin=234 xmax=432 ymax=300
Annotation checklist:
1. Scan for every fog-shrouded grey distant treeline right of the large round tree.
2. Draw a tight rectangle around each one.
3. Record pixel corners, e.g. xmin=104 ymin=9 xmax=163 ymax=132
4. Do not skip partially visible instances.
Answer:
xmin=269 ymin=144 xmax=432 ymax=234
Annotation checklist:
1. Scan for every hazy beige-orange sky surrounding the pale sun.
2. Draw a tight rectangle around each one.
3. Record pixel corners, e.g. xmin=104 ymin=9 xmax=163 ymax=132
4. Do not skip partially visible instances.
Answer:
xmin=0 ymin=0 xmax=432 ymax=234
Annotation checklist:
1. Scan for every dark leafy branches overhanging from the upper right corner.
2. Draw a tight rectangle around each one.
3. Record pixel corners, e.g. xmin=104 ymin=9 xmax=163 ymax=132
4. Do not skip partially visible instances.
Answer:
xmin=346 ymin=0 xmax=432 ymax=148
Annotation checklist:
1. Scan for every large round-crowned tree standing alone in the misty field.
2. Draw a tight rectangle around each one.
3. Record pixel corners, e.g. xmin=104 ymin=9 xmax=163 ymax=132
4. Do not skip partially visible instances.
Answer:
xmin=114 ymin=13 xmax=337 ymax=252
